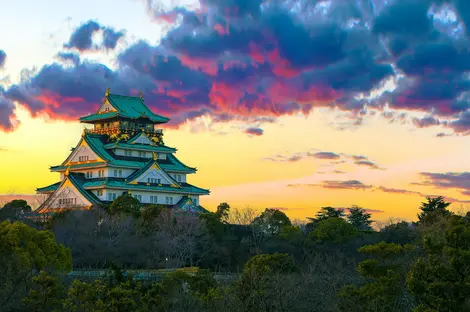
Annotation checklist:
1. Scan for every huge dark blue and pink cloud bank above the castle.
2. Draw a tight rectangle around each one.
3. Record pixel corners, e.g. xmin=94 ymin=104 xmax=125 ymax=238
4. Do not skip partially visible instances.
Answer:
xmin=4 ymin=0 xmax=470 ymax=134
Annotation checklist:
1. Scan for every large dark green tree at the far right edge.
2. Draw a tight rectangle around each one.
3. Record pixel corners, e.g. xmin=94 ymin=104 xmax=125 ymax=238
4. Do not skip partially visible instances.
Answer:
xmin=407 ymin=216 xmax=470 ymax=312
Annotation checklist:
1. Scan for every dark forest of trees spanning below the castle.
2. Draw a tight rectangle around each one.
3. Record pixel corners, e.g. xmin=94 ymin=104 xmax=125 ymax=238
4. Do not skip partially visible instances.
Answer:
xmin=0 ymin=195 xmax=470 ymax=312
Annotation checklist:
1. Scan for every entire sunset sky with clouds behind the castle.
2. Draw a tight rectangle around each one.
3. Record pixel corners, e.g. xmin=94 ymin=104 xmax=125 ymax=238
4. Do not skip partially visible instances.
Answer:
xmin=0 ymin=0 xmax=470 ymax=220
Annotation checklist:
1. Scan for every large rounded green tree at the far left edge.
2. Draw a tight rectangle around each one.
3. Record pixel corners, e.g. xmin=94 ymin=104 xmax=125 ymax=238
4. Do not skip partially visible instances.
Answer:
xmin=0 ymin=221 xmax=72 ymax=310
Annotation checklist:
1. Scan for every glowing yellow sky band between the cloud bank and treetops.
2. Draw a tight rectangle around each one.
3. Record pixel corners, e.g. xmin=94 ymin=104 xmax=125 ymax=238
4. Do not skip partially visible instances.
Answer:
xmin=0 ymin=107 xmax=470 ymax=220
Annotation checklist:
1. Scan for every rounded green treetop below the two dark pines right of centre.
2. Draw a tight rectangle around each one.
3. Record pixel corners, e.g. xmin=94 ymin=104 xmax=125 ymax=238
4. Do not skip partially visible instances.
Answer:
xmin=309 ymin=217 xmax=357 ymax=244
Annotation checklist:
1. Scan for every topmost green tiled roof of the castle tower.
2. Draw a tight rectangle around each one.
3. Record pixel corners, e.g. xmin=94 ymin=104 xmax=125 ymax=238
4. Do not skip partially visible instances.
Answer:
xmin=80 ymin=94 xmax=170 ymax=123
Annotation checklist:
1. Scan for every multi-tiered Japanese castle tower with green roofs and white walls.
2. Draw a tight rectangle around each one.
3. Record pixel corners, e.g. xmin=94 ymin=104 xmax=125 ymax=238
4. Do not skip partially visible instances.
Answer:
xmin=36 ymin=89 xmax=209 ymax=213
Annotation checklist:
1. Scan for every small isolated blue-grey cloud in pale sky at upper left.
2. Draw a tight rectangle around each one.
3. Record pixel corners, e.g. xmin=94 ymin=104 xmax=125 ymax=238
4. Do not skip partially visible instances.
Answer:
xmin=64 ymin=20 xmax=124 ymax=52
